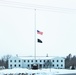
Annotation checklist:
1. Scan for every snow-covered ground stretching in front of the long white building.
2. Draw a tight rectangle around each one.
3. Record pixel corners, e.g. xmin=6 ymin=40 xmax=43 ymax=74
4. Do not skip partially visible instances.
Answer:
xmin=0 ymin=68 xmax=76 ymax=75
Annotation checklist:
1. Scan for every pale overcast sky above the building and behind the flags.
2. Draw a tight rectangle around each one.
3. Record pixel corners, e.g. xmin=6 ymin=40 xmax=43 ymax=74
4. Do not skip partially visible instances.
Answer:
xmin=0 ymin=0 xmax=76 ymax=56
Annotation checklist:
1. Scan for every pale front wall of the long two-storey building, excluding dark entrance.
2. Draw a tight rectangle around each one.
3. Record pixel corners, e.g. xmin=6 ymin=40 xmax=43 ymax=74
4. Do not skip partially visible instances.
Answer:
xmin=8 ymin=57 xmax=65 ymax=68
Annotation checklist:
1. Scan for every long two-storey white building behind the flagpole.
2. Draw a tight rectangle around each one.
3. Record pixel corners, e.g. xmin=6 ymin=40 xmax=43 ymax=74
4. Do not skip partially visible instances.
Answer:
xmin=8 ymin=56 xmax=65 ymax=69
